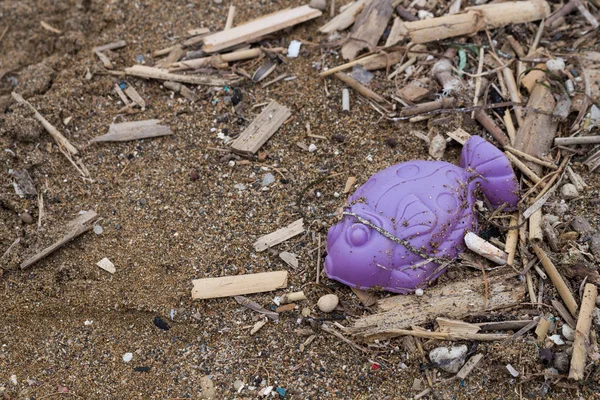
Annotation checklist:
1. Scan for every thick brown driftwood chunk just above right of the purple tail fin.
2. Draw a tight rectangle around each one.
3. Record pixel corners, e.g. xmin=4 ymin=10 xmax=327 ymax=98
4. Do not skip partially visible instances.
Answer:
xmin=513 ymin=80 xmax=558 ymax=175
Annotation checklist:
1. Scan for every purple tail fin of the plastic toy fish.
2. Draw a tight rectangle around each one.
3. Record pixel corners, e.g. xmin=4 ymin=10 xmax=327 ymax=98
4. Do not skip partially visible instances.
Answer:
xmin=460 ymin=136 xmax=519 ymax=210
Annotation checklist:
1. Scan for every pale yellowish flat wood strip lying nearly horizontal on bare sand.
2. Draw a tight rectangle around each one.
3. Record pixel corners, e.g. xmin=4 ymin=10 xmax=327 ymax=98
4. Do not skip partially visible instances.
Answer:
xmin=192 ymin=271 xmax=288 ymax=300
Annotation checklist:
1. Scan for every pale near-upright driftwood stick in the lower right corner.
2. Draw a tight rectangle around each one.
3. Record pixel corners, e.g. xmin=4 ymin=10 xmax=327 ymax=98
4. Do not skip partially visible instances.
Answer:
xmin=569 ymin=283 xmax=598 ymax=381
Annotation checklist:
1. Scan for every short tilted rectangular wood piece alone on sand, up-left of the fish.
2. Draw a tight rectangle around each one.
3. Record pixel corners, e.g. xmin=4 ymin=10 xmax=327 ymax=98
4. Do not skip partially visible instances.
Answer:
xmin=231 ymin=101 xmax=292 ymax=153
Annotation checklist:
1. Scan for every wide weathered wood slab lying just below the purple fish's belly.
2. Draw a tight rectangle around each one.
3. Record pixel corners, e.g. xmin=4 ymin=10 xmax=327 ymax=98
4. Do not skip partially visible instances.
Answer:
xmin=349 ymin=275 xmax=525 ymax=338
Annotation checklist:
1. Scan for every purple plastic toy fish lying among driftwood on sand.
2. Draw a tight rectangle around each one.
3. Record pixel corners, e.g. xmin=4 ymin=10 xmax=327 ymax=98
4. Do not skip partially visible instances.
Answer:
xmin=325 ymin=136 xmax=518 ymax=293
